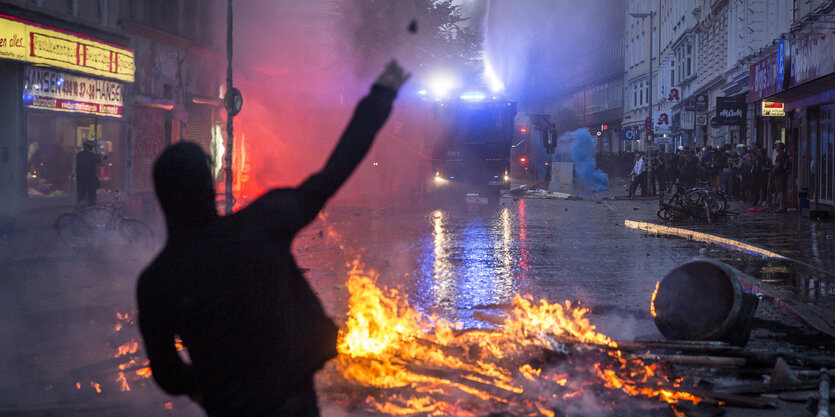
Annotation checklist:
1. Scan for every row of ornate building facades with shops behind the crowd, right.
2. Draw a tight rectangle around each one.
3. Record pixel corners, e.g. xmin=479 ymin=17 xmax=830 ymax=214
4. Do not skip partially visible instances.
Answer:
xmin=612 ymin=0 xmax=835 ymax=211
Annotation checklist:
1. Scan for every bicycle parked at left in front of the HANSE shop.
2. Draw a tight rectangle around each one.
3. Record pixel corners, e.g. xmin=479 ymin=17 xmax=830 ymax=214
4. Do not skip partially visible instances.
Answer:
xmin=54 ymin=192 xmax=154 ymax=249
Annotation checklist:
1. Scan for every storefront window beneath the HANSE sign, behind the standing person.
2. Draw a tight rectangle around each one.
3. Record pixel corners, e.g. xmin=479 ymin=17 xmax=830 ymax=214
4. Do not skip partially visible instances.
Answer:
xmin=26 ymin=112 xmax=125 ymax=197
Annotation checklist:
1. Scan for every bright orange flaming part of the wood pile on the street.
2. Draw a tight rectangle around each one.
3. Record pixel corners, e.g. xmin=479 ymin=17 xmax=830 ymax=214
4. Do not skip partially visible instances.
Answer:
xmin=321 ymin=263 xmax=701 ymax=417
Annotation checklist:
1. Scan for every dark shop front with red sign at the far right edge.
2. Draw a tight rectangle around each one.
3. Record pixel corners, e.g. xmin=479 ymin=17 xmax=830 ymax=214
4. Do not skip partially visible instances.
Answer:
xmin=749 ymin=34 xmax=835 ymax=212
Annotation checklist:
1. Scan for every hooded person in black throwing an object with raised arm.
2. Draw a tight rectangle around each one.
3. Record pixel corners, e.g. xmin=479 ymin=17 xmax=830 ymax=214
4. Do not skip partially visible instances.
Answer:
xmin=137 ymin=61 xmax=409 ymax=416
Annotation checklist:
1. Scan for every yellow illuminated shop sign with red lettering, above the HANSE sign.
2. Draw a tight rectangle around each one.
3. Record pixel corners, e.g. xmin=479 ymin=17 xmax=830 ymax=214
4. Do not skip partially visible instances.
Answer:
xmin=0 ymin=15 xmax=134 ymax=82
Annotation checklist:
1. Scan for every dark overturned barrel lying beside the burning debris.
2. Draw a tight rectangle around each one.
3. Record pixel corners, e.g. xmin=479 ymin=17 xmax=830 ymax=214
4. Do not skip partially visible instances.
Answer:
xmin=653 ymin=259 xmax=758 ymax=346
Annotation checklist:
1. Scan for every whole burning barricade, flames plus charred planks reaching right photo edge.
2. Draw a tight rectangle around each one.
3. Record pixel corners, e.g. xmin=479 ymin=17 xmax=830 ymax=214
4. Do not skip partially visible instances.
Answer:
xmin=319 ymin=262 xmax=835 ymax=417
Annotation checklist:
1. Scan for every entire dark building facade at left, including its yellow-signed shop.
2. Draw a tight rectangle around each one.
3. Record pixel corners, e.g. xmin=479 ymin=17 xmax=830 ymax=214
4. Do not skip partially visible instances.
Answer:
xmin=0 ymin=0 xmax=224 ymax=228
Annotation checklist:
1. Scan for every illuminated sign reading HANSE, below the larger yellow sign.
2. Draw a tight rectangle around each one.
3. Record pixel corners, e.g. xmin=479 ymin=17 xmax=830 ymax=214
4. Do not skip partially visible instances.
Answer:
xmin=23 ymin=66 xmax=123 ymax=117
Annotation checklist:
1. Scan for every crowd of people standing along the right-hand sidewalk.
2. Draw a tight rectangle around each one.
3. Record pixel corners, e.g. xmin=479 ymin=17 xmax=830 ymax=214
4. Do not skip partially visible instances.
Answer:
xmin=599 ymin=142 xmax=791 ymax=213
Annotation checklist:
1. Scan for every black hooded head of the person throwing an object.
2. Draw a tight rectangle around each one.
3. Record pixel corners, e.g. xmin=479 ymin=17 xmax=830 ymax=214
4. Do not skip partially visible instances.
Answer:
xmin=154 ymin=142 xmax=217 ymax=229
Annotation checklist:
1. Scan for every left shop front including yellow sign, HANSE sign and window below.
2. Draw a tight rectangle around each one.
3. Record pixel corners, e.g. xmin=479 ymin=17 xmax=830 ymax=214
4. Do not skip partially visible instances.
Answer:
xmin=0 ymin=15 xmax=133 ymax=225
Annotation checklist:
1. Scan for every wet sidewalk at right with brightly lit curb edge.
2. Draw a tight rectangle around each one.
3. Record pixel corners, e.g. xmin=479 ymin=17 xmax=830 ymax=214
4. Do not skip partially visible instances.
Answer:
xmin=606 ymin=188 xmax=835 ymax=336
